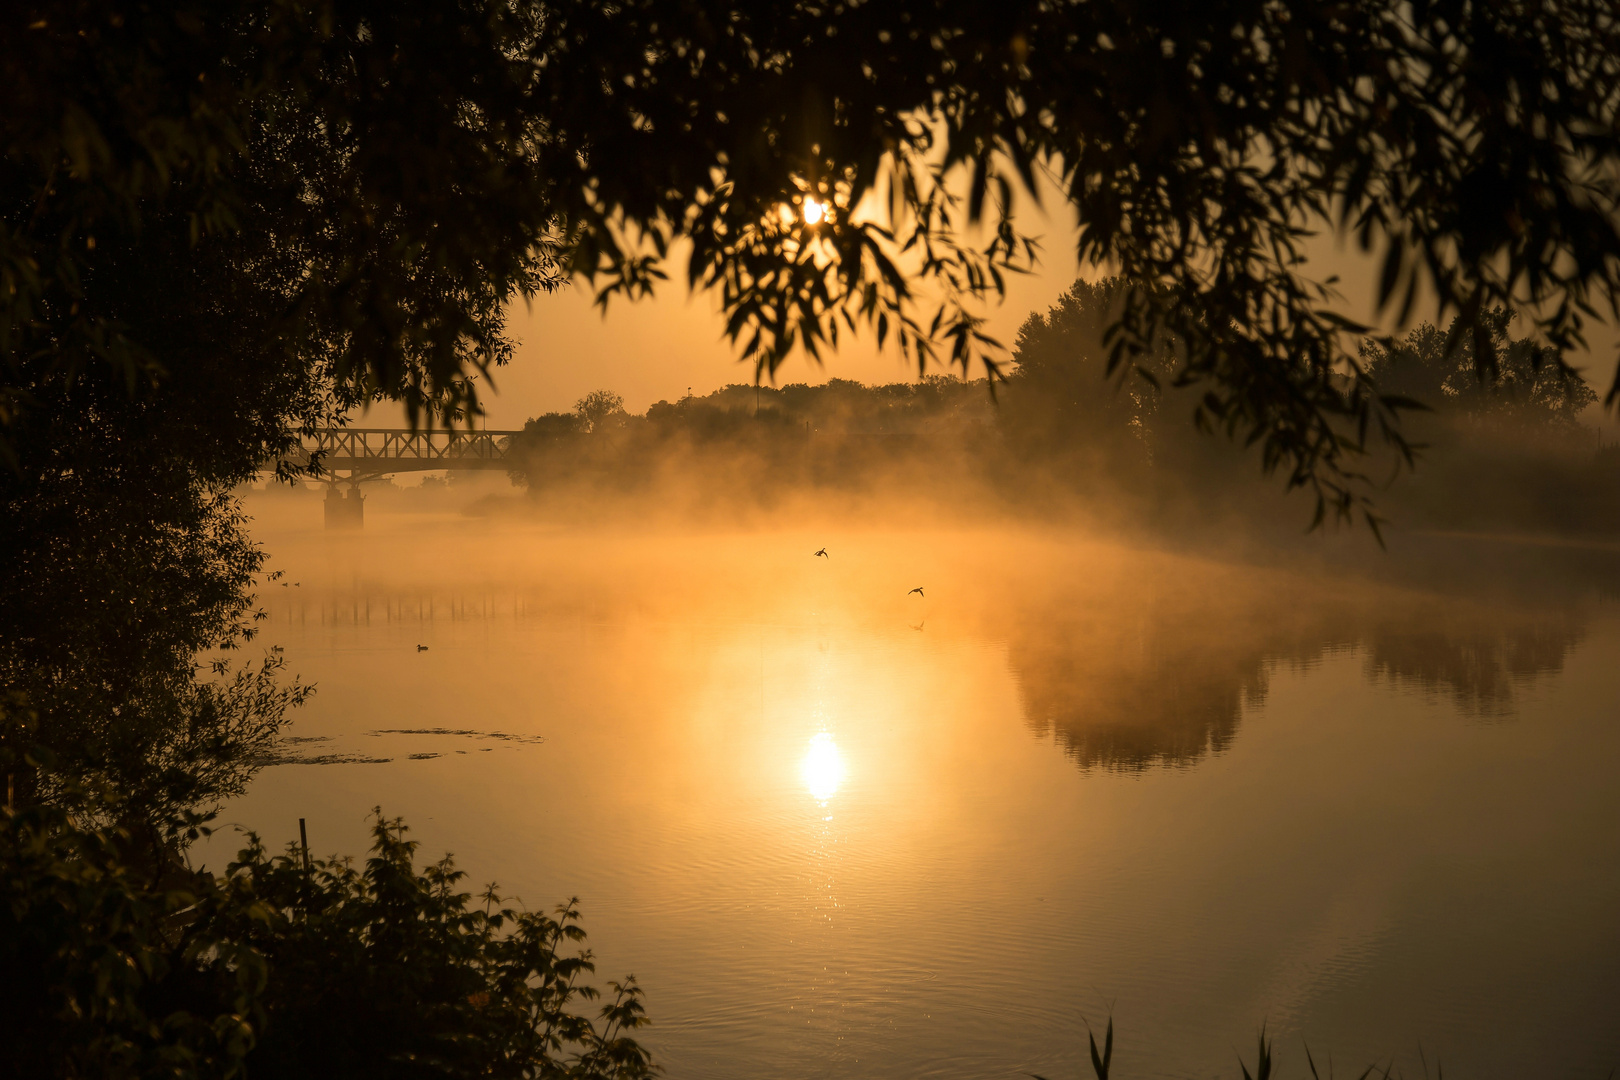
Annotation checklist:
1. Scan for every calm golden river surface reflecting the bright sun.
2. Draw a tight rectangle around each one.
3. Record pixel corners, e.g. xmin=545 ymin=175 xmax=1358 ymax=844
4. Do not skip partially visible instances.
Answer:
xmin=204 ymin=502 xmax=1620 ymax=1078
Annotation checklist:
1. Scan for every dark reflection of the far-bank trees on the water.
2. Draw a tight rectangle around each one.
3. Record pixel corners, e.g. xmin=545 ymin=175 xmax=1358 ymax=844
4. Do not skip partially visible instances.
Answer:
xmin=1006 ymin=560 xmax=1586 ymax=771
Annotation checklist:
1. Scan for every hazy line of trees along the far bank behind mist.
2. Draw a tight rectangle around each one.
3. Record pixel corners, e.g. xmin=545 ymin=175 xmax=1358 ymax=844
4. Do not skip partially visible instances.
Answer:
xmin=510 ymin=279 xmax=1620 ymax=533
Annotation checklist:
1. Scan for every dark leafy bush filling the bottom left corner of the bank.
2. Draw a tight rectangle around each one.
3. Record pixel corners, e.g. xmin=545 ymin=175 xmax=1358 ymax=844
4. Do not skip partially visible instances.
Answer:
xmin=0 ymin=786 xmax=656 ymax=1080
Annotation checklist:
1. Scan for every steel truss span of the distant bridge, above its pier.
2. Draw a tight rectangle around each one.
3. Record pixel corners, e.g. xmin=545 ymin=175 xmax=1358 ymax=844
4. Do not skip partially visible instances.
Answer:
xmin=287 ymin=427 xmax=522 ymax=484
